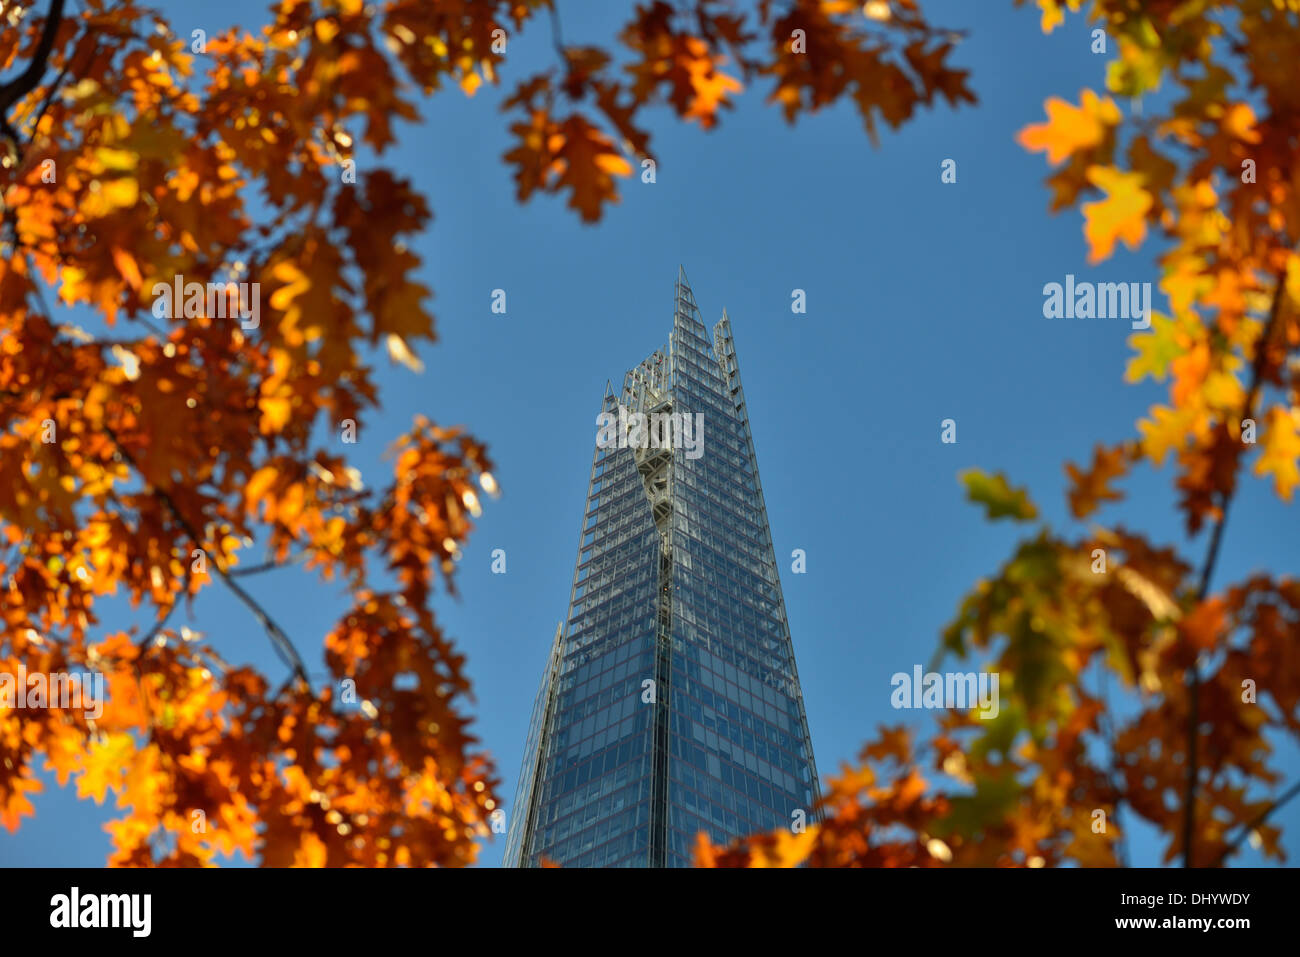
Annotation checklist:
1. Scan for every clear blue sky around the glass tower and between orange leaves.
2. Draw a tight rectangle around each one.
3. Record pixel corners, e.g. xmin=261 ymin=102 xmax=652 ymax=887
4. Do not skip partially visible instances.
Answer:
xmin=0 ymin=0 xmax=1300 ymax=866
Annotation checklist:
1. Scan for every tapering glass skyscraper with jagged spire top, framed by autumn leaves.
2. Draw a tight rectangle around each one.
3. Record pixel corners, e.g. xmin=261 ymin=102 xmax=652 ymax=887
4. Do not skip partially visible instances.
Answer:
xmin=506 ymin=272 xmax=818 ymax=867
